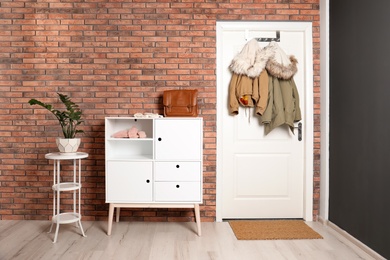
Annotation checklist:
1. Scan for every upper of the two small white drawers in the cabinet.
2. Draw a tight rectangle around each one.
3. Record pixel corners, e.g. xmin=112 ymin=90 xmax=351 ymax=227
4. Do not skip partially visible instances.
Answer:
xmin=154 ymin=162 xmax=202 ymax=181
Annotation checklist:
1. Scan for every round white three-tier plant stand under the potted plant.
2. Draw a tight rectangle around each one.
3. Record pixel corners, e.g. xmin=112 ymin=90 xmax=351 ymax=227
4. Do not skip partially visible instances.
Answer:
xmin=45 ymin=152 xmax=88 ymax=243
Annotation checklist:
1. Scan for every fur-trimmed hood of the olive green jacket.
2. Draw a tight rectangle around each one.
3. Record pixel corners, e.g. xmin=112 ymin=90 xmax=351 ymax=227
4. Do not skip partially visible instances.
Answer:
xmin=266 ymin=42 xmax=298 ymax=80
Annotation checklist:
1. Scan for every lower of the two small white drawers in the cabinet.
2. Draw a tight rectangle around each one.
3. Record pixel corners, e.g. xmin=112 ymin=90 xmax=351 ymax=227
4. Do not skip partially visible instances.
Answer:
xmin=154 ymin=182 xmax=201 ymax=202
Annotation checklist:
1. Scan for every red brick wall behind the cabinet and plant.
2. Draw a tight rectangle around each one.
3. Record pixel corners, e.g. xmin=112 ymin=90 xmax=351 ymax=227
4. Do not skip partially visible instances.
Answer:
xmin=0 ymin=0 xmax=320 ymax=221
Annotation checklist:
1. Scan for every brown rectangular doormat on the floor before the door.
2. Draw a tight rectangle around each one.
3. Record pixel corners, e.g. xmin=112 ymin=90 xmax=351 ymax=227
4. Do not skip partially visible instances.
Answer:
xmin=229 ymin=220 xmax=322 ymax=240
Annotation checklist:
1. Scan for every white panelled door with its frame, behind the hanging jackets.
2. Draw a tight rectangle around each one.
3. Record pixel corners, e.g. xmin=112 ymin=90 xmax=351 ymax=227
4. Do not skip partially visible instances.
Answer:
xmin=217 ymin=22 xmax=313 ymax=220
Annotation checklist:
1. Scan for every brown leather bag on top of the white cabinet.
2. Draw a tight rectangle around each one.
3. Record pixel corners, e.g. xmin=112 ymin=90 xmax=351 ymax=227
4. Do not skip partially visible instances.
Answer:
xmin=163 ymin=89 xmax=198 ymax=117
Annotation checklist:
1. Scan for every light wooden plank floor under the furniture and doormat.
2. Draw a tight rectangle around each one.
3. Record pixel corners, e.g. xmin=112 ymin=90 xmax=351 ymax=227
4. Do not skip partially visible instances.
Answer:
xmin=0 ymin=220 xmax=373 ymax=260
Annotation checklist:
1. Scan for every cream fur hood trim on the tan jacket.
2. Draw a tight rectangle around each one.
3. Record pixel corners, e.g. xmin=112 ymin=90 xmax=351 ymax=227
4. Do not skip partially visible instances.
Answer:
xmin=229 ymin=39 xmax=274 ymax=78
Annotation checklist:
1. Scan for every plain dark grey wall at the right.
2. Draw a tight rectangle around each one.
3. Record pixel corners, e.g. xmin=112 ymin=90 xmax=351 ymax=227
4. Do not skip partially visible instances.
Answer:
xmin=329 ymin=0 xmax=390 ymax=258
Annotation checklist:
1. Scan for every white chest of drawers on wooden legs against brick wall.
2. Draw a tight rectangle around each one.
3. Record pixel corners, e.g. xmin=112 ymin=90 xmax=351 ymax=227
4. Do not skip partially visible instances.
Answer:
xmin=105 ymin=117 xmax=203 ymax=235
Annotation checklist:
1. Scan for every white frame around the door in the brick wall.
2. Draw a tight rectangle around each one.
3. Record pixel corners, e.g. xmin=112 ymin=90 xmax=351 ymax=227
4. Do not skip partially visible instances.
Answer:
xmin=216 ymin=21 xmax=314 ymax=222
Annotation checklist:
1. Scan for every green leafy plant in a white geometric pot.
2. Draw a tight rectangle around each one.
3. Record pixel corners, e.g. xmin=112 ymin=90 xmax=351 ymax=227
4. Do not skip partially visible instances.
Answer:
xmin=28 ymin=93 xmax=84 ymax=154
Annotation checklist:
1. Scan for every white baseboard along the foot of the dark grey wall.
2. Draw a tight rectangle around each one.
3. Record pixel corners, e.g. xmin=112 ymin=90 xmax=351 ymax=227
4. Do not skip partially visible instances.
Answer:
xmin=318 ymin=217 xmax=386 ymax=260
